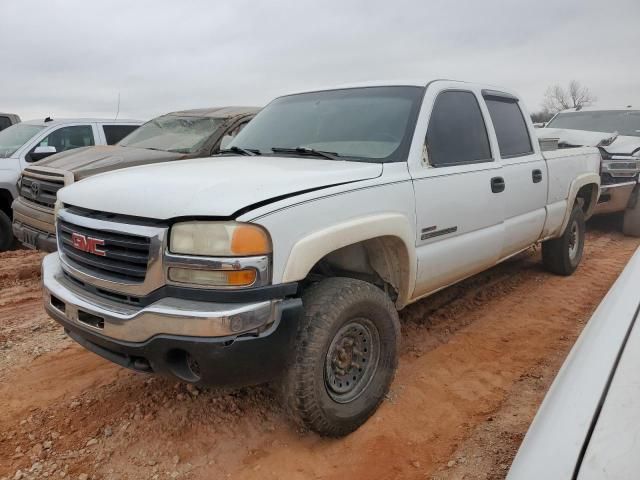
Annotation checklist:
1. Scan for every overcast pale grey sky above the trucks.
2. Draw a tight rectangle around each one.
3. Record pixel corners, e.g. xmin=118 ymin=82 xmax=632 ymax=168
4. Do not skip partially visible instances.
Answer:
xmin=0 ymin=0 xmax=640 ymax=120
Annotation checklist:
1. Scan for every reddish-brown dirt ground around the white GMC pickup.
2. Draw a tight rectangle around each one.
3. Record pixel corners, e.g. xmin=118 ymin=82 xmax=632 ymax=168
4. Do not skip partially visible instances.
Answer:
xmin=0 ymin=225 xmax=638 ymax=479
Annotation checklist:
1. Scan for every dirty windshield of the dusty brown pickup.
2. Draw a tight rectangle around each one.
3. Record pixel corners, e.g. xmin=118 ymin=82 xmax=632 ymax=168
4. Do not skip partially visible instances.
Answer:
xmin=118 ymin=115 xmax=223 ymax=153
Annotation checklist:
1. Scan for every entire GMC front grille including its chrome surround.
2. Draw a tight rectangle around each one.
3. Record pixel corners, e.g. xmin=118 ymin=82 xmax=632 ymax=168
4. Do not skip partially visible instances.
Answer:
xmin=56 ymin=207 xmax=167 ymax=296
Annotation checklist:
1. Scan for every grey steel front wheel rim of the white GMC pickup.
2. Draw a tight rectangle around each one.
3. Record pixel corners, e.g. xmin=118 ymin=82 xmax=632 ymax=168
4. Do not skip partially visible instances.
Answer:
xmin=324 ymin=318 xmax=381 ymax=403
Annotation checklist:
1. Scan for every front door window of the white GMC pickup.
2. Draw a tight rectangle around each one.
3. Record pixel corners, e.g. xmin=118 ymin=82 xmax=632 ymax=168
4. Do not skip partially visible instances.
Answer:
xmin=426 ymin=90 xmax=492 ymax=167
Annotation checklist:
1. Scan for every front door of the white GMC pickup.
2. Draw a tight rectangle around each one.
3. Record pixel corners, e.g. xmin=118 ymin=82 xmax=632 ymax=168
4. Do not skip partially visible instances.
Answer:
xmin=411 ymin=87 xmax=504 ymax=297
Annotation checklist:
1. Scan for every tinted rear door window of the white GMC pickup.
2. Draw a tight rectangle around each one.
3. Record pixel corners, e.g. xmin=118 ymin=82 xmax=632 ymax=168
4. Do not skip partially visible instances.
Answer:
xmin=485 ymin=96 xmax=533 ymax=158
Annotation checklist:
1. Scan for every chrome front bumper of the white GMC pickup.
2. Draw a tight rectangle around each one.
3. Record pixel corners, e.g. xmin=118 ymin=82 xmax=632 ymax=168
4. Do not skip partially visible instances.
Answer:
xmin=42 ymin=253 xmax=282 ymax=342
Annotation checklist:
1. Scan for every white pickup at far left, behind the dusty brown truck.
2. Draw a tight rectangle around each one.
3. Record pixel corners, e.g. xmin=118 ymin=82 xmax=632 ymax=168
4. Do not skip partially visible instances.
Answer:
xmin=0 ymin=117 xmax=142 ymax=252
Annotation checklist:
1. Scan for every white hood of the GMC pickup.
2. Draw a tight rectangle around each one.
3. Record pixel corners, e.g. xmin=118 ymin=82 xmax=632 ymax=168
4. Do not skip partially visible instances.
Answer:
xmin=58 ymin=156 xmax=382 ymax=220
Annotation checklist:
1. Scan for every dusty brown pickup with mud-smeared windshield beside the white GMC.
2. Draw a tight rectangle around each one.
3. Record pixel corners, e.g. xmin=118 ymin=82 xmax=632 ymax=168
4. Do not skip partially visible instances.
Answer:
xmin=13 ymin=107 xmax=258 ymax=252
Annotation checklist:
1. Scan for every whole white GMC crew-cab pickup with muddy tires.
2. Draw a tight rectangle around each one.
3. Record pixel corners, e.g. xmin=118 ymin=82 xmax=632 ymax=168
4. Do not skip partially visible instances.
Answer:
xmin=43 ymin=81 xmax=600 ymax=436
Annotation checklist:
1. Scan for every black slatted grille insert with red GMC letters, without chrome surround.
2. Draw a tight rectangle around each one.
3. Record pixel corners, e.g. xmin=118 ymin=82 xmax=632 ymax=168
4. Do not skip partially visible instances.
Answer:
xmin=57 ymin=220 xmax=151 ymax=283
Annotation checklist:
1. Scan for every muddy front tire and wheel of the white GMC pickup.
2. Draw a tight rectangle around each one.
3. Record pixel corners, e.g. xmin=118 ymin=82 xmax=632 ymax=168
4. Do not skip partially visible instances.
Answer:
xmin=283 ymin=278 xmax=400 ymax=437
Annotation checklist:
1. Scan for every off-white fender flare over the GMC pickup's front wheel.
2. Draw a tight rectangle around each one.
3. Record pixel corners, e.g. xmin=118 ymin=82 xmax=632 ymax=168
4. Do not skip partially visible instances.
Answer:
xmin=282 ymin=213 xmax=417 ymax=307
